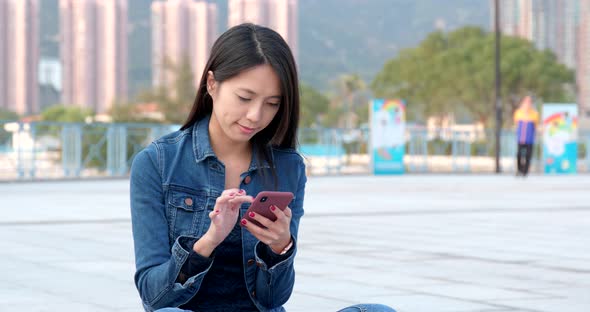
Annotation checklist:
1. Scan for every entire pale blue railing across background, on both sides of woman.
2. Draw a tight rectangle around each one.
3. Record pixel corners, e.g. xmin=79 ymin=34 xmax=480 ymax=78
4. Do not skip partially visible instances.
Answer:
xmin=0 ymin=121 xmax=590 ymax=181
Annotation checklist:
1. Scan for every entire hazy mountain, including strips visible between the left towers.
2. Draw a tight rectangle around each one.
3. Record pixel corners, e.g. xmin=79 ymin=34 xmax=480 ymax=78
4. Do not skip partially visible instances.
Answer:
xmin=40 ymin=0 xmax=490 ymax=98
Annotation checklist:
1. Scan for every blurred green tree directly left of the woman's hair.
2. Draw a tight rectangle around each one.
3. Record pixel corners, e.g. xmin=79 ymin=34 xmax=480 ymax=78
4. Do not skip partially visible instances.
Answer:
xmin=139 ymin=57 xmax=196 ymax=124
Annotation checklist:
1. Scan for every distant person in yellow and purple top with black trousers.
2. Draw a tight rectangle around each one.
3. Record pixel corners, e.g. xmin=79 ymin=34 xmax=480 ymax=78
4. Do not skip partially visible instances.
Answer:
xmin=514 ymin=96 xmax=539 ymax=177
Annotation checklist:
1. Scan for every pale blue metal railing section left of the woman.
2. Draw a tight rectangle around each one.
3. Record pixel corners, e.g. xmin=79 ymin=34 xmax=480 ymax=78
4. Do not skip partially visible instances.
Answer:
xmin=0 ymin=122 xmax=178 ymax=180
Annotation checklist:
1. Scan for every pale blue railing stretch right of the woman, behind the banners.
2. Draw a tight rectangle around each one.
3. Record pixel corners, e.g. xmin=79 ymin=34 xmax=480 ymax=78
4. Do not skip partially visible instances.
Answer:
xmin=299 ymin=128 xmax=590 ymax=174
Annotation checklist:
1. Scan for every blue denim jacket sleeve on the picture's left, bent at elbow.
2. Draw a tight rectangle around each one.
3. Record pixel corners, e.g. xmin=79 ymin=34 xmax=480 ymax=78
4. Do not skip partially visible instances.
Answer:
xmin=130 ymin=144 xmax=213 ymax=311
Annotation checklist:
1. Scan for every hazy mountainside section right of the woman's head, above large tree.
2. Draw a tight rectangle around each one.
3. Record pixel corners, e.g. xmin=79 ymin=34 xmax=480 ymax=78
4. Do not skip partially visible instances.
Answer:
xmin=299 ymin=0 xmax=490 ymax=90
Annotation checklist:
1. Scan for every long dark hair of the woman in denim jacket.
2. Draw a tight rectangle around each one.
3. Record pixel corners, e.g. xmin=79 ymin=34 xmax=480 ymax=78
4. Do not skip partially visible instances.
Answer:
xmin=181 ymin=23 xmax=299 ymax=172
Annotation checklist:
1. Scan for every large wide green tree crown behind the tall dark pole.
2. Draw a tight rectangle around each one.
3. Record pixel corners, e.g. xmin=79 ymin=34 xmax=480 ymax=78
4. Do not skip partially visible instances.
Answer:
xmin=371 ymin=27 xmax=574 ymax=124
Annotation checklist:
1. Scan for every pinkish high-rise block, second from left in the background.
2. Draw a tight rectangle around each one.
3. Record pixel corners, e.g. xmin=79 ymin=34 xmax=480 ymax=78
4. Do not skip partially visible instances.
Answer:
xmin=59 ymin=0 xmax=128 ymax=113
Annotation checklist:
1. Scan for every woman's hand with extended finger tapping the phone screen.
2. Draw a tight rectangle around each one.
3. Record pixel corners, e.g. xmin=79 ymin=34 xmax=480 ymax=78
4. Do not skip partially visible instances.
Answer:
xmin=193 ymin=189 xmax=254 ymax=257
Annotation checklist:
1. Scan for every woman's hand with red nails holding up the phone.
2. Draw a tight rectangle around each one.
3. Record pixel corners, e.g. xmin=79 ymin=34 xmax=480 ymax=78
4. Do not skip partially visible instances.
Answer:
xmin=240 ymin=205 xmax=292 ymax=254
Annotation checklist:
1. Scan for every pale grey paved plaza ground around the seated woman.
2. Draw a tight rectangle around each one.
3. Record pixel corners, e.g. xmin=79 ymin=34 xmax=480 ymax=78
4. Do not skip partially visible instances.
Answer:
xmin=0 ymin=175 xmax=590 ymax=312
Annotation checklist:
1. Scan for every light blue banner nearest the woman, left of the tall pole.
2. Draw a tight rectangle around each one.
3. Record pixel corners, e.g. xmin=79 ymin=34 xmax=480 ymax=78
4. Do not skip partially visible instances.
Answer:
xmin=369 ymin=99 xmax=406 ymax=174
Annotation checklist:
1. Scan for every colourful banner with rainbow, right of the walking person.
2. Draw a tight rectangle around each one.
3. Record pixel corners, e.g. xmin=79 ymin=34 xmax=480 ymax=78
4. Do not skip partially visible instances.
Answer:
xmin=543 ymin=103 xmax=578 ymax=173
